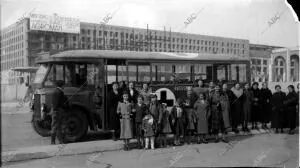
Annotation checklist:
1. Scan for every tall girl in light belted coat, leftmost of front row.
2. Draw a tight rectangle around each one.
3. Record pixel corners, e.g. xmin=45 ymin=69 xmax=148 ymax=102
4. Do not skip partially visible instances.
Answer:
xmin=117 ymin=92 xmax=133 ymax=150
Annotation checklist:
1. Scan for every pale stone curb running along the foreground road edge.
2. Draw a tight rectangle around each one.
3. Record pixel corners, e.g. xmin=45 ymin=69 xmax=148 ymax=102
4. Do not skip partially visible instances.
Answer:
xmin=2 ymin=130 xmax=274 ymax=165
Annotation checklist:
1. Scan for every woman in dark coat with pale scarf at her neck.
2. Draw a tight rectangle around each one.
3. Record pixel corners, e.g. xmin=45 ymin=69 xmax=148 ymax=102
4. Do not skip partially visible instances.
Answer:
xmin=231 ymin=83 xmax=245 ymax=134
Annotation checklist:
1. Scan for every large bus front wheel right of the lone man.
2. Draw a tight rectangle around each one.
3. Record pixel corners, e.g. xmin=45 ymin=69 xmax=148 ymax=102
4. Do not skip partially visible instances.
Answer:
xmin=62 ymin=109 xmax=88 ymax=142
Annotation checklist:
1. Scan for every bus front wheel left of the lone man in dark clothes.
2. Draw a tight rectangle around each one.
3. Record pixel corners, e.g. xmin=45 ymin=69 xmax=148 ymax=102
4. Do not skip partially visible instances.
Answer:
xmin=32 ymin=118 xmax=51 ymax=137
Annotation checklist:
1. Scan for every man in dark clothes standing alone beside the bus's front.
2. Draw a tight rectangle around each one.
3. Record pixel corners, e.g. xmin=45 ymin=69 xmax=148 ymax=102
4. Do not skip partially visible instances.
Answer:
xmin=51 ymin=80 xmax=67 ymax=144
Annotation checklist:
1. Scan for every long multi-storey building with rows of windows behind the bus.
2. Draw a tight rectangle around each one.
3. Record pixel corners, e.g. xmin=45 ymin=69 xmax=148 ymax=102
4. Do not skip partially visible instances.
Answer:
xmin=1 ymin=12 xmax=292 ymax=86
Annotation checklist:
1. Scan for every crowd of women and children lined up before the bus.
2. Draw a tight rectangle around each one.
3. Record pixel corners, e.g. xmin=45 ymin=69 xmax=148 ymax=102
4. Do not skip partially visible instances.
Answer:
xmin=107 ymin=80 xmax=299 ymax=150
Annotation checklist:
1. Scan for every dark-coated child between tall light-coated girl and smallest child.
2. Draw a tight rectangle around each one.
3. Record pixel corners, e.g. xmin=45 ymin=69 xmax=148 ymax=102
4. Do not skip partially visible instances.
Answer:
xmin=133 ymin=95 xmax=148 ymax=149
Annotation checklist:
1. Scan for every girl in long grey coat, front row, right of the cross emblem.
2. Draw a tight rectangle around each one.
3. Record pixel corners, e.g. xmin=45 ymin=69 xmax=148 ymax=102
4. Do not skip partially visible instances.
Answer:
xmin=194 ymin=93 xmax=210 ymax=144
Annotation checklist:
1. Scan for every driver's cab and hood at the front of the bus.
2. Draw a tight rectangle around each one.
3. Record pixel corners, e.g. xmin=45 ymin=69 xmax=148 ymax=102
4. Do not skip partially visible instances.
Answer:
xmin=34 ymin=61 xmax=104 ymax=131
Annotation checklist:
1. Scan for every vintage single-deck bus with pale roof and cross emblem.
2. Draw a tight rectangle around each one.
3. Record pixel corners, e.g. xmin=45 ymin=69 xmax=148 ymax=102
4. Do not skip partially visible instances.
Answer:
xmin=32 ymin=50 xmax=250 ymax=142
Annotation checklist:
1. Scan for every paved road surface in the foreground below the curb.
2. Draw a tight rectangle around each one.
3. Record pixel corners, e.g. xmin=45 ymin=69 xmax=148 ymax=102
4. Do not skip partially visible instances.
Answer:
xmin=7 ymin=134 xmax=299 ymax=168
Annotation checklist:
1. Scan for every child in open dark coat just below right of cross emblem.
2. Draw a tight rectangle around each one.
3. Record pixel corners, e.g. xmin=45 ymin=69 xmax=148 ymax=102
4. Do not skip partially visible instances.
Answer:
xmin=171 ymin=99 xmax=185 ymax=145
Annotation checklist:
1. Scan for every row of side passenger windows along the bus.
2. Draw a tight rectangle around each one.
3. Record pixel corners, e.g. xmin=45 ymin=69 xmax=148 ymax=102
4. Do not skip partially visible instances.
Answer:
xmin=107 ymin=64 xmax=246 ymax=83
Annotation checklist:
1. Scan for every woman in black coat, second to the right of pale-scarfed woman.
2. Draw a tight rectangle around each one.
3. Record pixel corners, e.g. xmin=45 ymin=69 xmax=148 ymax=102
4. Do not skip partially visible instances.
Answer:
xmin=251 ymin=82 xmax=261 ymax=129
